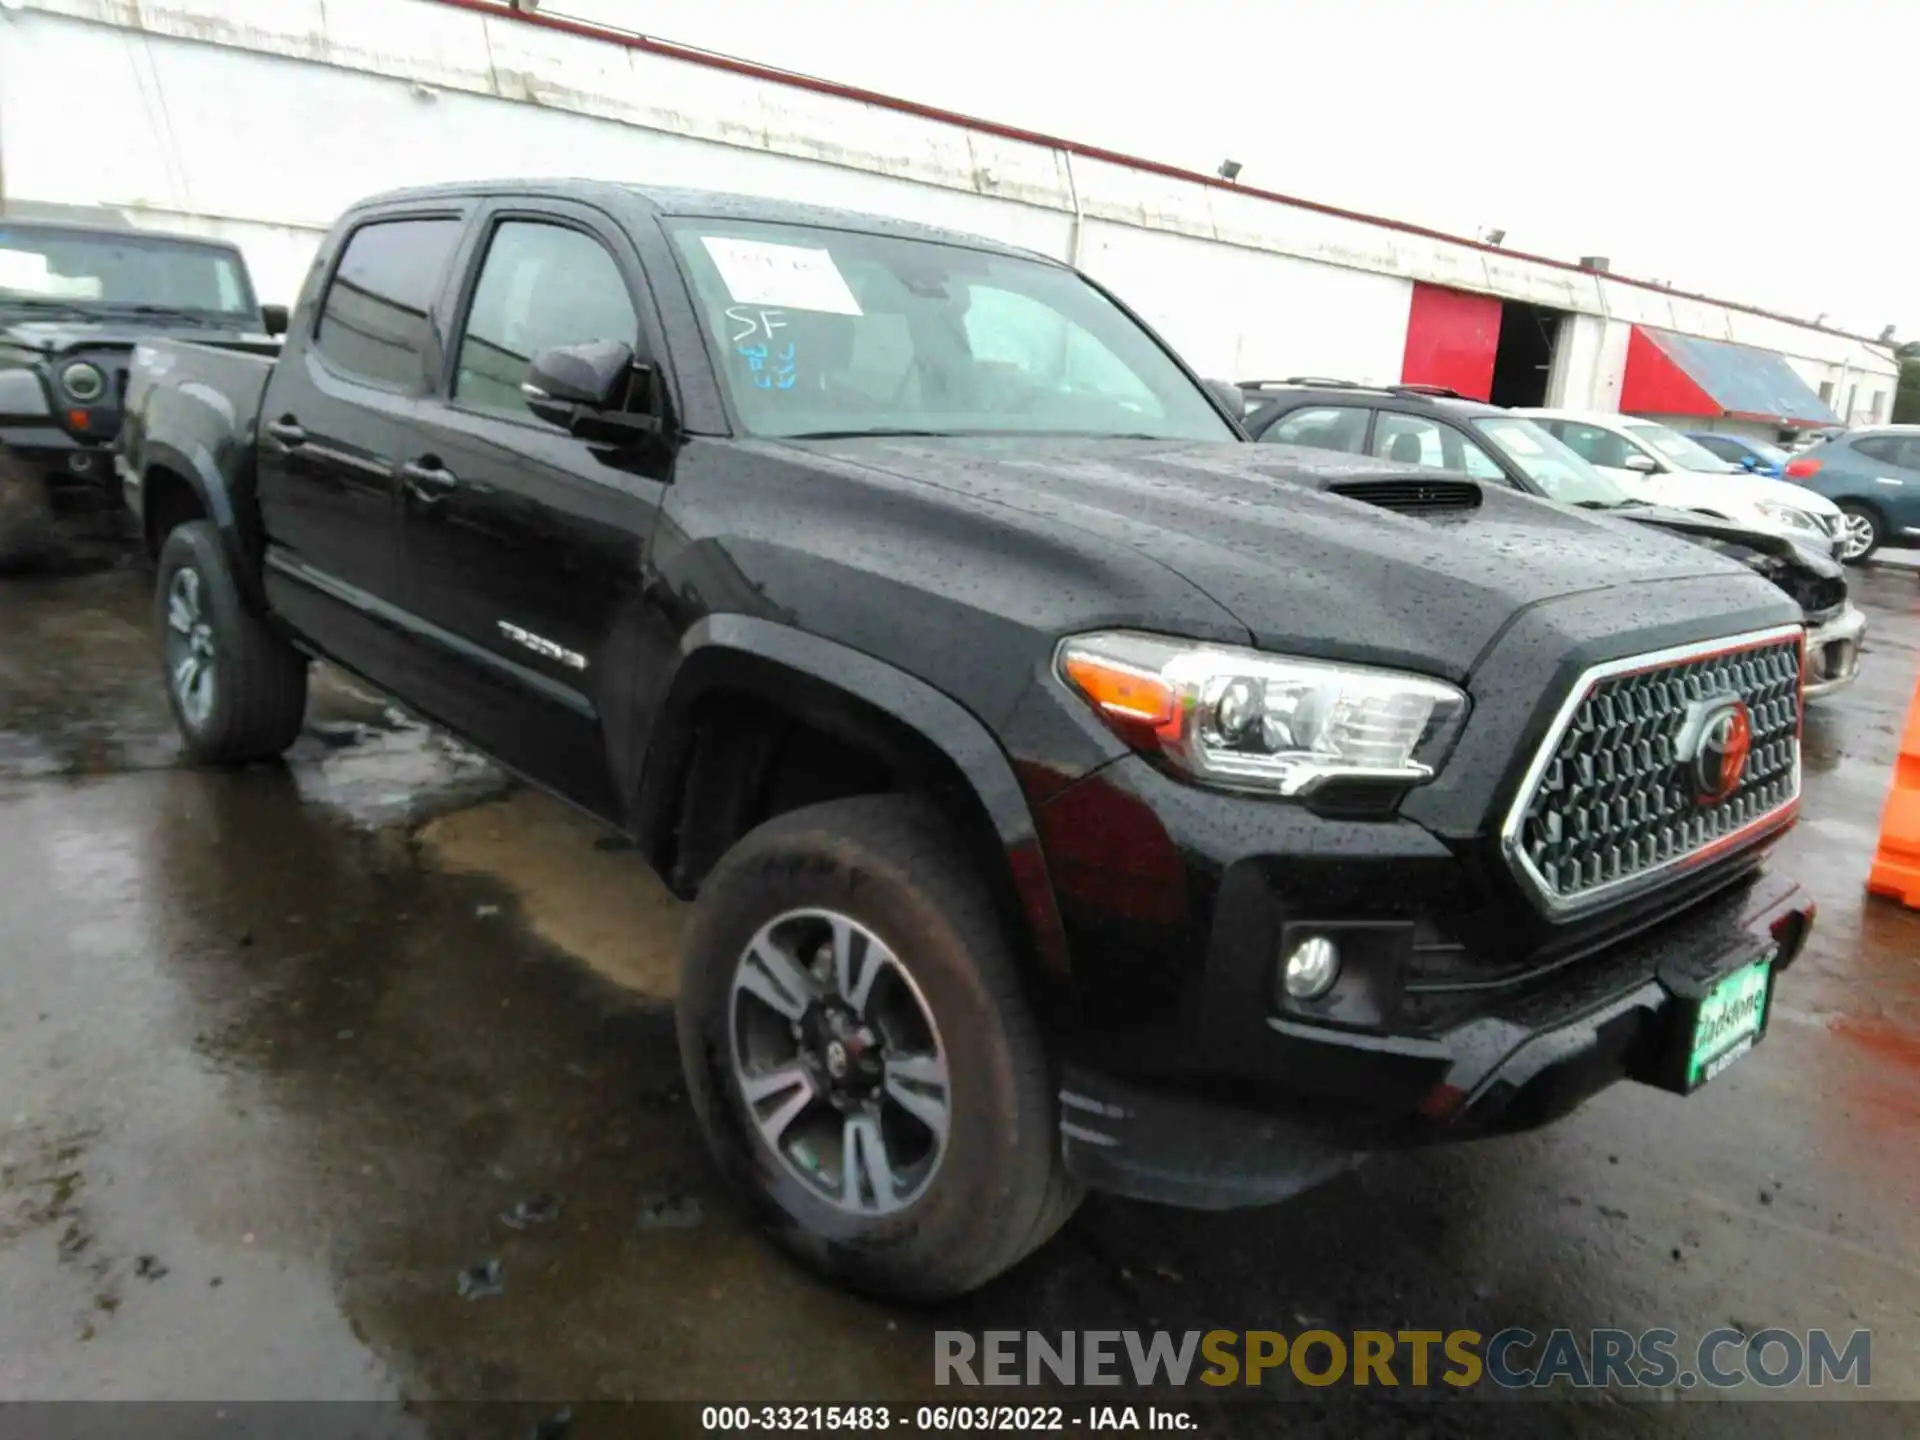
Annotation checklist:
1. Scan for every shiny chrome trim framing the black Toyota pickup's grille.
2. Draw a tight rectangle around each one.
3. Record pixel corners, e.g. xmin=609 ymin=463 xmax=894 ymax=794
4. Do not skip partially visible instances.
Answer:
xmin=1500 ymin=626 xmax=1807 ymax=918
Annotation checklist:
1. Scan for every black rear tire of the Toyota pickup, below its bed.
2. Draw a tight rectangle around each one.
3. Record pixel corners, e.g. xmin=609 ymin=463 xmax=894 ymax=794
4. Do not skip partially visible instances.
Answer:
xmin=154 ymin=520 xmax=307 ymax=764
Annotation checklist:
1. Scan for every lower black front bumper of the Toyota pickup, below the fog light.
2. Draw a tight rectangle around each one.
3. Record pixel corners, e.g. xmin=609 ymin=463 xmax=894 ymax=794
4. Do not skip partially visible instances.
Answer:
xmin=1060 ymin=876 xmax=1812 ymax=1210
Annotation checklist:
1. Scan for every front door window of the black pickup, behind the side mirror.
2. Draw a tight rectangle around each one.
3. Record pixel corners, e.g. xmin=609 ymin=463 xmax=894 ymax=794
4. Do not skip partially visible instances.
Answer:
xmin=453 ymin=221 xmax=639 ymax=415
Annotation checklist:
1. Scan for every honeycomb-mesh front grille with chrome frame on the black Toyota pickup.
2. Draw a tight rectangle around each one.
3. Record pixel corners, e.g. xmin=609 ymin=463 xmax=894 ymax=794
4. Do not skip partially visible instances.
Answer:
xmin=1505 ymin=628 xmax=1801 ymax=910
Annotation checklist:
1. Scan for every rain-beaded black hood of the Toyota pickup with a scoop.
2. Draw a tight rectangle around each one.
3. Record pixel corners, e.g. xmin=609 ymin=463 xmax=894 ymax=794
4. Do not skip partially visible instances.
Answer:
xmin=766 ymin=438 xmax=1768 ymax=680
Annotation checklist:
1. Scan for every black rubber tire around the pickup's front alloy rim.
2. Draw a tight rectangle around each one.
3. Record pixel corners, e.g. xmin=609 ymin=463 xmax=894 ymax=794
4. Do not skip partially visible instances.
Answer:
xmin=680 ymin=795 xmax=1081 ymax=1300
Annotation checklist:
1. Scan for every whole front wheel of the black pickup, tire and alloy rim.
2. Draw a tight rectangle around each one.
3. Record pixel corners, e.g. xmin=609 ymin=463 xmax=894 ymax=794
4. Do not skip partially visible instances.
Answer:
xmin=680 ymin=797 xmax=1079 ymax=1300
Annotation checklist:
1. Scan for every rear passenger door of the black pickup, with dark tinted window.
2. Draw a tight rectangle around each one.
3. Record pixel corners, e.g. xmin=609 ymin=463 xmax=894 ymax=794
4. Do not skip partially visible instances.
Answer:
xmin=259 ymin=205 xmax=467 ymax=695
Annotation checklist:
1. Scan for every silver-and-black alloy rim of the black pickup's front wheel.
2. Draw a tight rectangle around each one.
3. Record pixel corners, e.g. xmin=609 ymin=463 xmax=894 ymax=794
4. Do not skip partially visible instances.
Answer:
xmin=728 ymin=910 xmax=952 ymax=1217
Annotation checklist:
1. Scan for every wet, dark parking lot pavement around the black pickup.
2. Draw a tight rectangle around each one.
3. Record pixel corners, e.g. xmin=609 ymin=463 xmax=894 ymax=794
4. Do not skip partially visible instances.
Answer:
xmin=0 ymin=566 xmax=1920 ymax=1434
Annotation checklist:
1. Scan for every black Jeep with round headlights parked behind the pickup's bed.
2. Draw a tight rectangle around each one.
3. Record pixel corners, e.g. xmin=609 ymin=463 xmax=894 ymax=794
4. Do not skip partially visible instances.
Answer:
xmin=0 ymin=215 xmax=286 ymax=574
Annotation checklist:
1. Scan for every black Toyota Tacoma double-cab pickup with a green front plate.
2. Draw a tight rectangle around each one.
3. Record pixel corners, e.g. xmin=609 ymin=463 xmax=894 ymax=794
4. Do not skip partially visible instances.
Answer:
xmin=123 ymin=182 xmax=1812 ymax=1296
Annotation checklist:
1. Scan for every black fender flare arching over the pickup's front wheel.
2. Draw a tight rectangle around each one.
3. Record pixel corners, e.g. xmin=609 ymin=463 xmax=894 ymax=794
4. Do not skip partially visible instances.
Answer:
xmin=634 ymin=614 xmax=1069 ymax=1006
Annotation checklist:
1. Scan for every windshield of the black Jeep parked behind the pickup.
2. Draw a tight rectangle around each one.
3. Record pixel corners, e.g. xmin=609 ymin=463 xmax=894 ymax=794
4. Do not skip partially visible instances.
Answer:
xmin=0 ymin=225 xmax=257 ymax=317
